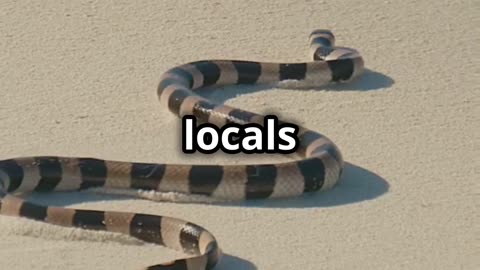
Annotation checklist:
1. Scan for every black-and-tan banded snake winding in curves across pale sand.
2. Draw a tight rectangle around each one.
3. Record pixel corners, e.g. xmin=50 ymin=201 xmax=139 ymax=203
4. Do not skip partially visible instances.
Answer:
xmin=0 ymin=29 xmax=364 ymax=270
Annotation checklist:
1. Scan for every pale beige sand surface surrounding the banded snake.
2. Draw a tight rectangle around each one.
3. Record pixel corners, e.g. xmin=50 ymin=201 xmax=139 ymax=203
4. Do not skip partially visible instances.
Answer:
xmin=0 ymin=0 xmax=480 ymax=270
